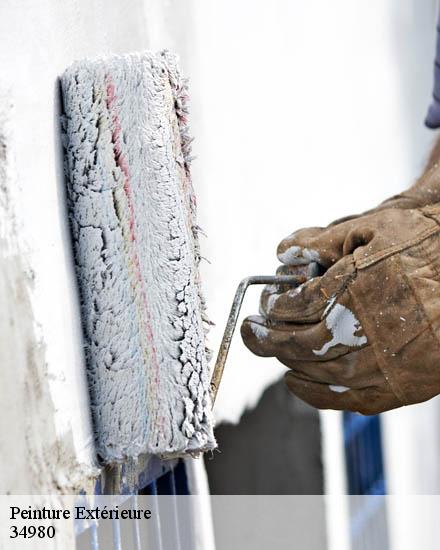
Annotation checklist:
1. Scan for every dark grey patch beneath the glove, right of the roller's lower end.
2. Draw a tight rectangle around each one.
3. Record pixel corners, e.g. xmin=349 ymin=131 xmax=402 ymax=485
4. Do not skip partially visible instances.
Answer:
xmin=205 ymin=380 xmax=323 ymax=495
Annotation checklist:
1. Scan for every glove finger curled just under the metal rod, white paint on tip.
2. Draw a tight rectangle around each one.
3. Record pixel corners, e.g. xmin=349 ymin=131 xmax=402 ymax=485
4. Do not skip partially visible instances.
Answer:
xmin=260 ymin=256 xmax=355 ymax=323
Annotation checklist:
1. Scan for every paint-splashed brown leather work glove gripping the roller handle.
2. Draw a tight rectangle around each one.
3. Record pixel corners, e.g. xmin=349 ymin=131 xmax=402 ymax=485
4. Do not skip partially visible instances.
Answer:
xmin=242 ymin=204 xmax=440 ymax=414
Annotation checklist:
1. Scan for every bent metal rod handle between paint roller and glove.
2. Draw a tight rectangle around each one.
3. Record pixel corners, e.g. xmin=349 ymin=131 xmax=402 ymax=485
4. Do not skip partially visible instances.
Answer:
xmin=211 ymin=275 xmax=301 ymax=407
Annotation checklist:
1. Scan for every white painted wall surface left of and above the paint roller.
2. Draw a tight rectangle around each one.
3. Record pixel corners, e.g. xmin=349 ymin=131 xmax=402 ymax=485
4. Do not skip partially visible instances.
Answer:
xmin=0 ymin=0 xmax=196 ymax=494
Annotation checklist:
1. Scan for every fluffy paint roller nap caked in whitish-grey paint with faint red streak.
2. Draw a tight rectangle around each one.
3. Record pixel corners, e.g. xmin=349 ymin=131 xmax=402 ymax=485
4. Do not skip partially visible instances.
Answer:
xmin=61 ymin=52 xmax=216 ymax=462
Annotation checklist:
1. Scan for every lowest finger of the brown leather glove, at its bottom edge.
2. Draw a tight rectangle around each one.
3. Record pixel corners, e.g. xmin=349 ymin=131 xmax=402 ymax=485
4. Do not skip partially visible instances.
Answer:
xmin=284 ymin=372 xmax=401 ymax=415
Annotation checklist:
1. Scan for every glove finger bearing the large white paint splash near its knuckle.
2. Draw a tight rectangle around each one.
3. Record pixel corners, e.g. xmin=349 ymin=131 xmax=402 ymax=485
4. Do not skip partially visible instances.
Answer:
xmin=241 ymin=304 xmax=367 ymax=361
